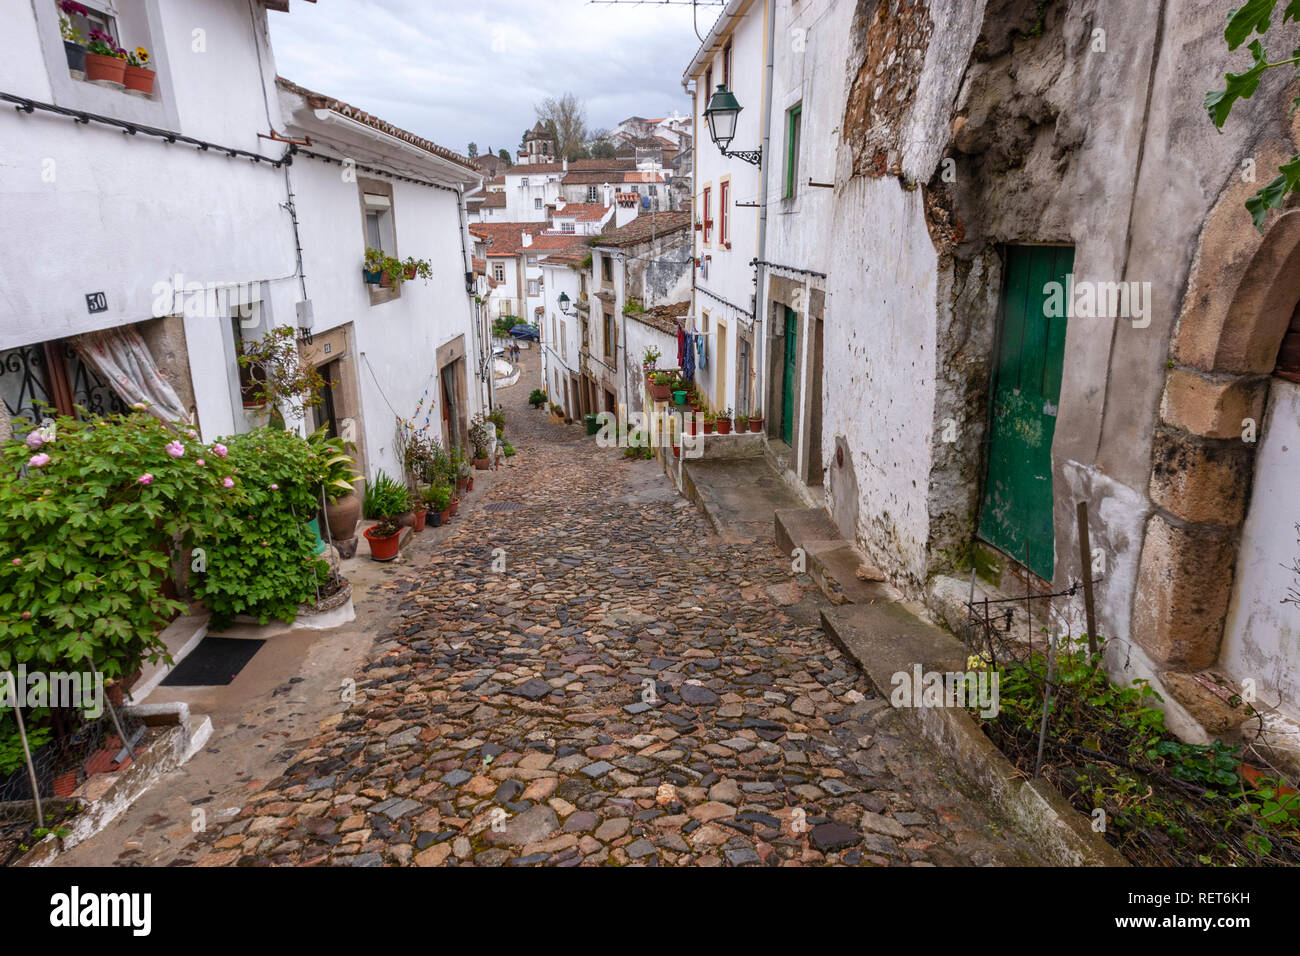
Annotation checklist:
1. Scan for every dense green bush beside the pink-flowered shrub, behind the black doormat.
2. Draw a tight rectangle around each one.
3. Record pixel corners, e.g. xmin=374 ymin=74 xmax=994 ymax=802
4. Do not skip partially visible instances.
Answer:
xmin=194 ymin=428 xmax=329 ymax=628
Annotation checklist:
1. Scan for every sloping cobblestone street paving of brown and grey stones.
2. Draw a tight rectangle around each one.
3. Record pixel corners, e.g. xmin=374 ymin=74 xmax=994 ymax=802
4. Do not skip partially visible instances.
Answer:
xmin=191 ymin=358 xmax=1036 ymax=866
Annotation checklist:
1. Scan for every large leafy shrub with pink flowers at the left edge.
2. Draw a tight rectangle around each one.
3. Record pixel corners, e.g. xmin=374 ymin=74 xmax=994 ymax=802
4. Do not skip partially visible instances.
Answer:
xmin=0 ymin=414 xmax=237 ymax=678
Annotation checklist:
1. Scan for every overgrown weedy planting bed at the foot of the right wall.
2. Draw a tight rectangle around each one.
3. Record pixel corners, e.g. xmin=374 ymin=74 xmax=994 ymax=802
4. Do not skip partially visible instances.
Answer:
xmin=965 ymin=581 xmax=1300 ymax=865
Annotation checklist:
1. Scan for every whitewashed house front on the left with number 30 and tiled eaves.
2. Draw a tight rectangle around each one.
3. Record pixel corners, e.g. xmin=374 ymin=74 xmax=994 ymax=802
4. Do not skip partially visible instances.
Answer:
xmin=0 ymin=0 xmax=489 ymax=477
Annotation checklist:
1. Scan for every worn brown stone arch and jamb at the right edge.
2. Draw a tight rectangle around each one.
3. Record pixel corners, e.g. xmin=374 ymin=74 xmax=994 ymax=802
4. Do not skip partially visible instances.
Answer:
xmin=1131 ymin=209 xmax=1300 ymax=670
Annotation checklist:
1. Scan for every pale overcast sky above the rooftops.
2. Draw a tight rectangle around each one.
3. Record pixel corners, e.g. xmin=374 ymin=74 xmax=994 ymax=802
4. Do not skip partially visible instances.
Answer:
xmin=268 ymin=0 xmax=722 ymax=156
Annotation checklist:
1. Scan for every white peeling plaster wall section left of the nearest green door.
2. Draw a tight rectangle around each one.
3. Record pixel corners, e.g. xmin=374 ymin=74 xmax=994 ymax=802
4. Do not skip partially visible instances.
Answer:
xmin=822 ymin=177 xmax=939 ymax=591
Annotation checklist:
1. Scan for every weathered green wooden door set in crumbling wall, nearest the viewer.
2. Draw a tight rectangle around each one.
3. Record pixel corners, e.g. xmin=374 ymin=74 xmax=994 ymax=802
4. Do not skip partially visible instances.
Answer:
xmin=979 ymin=246 xmax=1074 ymax=580
